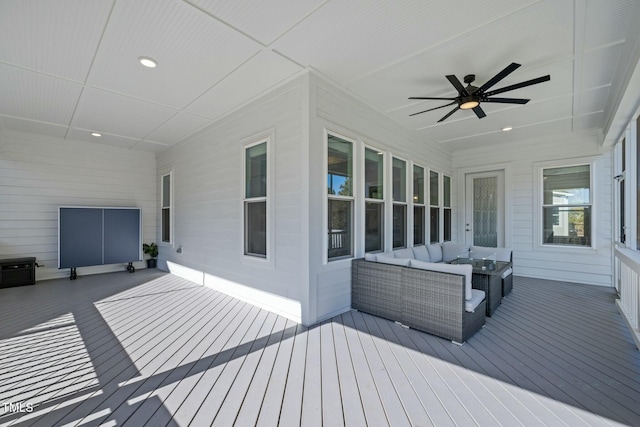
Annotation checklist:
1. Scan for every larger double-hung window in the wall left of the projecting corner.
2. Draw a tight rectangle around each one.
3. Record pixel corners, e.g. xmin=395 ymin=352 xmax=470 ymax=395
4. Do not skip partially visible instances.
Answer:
xmin=244 ymin=141 xmax=267 ymax=258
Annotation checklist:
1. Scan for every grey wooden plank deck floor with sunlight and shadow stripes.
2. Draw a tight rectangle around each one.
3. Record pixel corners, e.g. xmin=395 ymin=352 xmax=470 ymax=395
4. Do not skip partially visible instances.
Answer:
xmin=0 ymin=270 xmax=640 ymax=427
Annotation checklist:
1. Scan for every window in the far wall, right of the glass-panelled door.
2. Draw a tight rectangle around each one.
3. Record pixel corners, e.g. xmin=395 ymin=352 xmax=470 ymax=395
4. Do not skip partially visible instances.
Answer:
xmin=542 ymin=165 xmax=592 ymax=246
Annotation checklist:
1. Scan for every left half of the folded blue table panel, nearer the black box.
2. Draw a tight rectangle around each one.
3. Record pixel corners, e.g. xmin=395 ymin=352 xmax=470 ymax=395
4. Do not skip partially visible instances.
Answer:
xmin=58 ymin=208 xmax=102 ymax=268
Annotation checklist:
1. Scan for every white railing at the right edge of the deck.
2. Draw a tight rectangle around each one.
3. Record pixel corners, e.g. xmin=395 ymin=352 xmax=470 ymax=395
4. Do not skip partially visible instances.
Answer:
xmin=614 ymin=248 xmax=640 ymax=349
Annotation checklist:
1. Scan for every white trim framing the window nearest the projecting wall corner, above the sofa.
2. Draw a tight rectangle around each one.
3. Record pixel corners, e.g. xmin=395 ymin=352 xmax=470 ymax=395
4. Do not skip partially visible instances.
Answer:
xmin=322 ymin=128 xmax=361 ymax=265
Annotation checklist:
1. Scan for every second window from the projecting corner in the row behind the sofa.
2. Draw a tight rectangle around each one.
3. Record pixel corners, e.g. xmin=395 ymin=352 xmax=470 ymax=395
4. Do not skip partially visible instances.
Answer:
xmin=364 ymin=148 xmax=384 ymax=252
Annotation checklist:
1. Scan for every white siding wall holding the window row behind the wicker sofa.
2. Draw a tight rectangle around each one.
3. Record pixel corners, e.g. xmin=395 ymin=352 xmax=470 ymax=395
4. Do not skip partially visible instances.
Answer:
xmin=309 ymin=74 xmax=456 ymax=322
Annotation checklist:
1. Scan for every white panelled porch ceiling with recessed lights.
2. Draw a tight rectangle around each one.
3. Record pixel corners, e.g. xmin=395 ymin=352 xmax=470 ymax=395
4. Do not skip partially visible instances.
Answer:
xmin=0 ymin=0 xmax=640 ymax=151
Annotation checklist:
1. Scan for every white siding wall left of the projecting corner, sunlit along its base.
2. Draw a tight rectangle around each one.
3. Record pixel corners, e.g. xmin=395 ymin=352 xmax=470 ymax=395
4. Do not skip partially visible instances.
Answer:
xmin=156 ymin=79 xmax=308 ymax=320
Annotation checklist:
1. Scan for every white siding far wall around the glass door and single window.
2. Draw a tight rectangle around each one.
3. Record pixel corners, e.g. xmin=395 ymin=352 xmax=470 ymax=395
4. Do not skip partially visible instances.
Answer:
xmin=453 ymin=131 xmax=613 ymax=286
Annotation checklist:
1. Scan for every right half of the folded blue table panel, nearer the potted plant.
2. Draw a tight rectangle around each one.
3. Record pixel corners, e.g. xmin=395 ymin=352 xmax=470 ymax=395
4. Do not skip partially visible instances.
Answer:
xmin=104 ymin=209 xmax=142 ymax=264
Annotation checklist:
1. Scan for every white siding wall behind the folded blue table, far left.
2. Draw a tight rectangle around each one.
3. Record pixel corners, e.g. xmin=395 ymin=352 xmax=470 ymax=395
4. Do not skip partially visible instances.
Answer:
xmin=0 ymin=131 xmax=156 ymax=280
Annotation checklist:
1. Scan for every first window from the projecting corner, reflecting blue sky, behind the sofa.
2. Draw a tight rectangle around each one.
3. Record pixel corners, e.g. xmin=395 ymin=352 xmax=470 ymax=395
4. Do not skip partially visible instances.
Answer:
xmin=327 ymin=135 xmax=353 ymax=260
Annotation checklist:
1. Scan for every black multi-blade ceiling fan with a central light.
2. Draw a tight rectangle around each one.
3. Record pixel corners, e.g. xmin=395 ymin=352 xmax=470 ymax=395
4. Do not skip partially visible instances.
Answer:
xmin=409 ymin=62 xmax=551 ymax=123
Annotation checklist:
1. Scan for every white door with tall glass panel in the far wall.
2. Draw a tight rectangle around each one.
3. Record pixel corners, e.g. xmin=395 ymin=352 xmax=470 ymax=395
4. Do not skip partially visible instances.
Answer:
xmin=464 ymin=170 xmax=504 ymax=248
